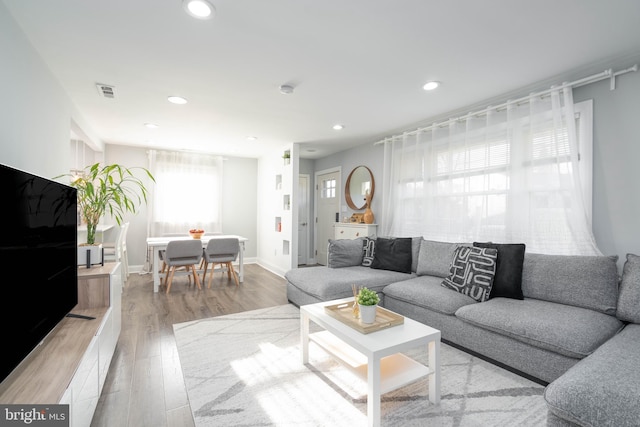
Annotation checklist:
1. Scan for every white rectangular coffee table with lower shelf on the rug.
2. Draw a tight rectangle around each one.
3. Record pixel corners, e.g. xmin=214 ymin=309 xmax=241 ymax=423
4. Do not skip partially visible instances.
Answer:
xmin=300 ymin=298 xmax=440 ymax=426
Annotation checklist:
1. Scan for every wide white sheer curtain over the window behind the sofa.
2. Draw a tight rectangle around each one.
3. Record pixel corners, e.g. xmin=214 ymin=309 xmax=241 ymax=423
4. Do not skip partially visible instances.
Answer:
xmin=381 ymin=88 xmax=601 ymax=255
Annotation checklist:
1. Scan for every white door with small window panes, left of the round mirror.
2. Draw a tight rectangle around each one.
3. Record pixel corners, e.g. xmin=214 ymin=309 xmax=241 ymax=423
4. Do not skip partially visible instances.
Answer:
xmin=316 ymin=171 xmax=341 ymax=265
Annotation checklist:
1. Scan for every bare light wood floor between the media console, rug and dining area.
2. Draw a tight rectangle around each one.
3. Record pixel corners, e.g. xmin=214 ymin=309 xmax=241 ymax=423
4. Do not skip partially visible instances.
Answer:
xmin=91 ymin=264 xmax=287 ymax=427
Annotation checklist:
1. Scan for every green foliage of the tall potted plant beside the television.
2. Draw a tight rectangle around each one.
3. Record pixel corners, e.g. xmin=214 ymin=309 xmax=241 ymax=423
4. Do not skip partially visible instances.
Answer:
xmin=56 ymin=163 xmax=155 ymax=266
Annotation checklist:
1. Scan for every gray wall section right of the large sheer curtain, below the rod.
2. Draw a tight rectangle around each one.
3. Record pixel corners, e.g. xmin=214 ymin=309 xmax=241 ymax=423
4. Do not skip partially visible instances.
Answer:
xmin=573 ymin=66 xmax=640 ymax=267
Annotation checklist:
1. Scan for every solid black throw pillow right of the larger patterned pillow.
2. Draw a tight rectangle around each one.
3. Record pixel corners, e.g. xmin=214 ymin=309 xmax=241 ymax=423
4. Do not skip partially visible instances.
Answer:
xmin=473 ymin=242 xmax=526 ymax=299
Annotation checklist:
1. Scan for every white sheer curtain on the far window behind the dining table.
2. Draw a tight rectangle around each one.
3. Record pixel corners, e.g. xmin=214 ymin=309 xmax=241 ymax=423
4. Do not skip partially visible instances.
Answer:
xmin=148 ymin=150 xmax=223 ymax=236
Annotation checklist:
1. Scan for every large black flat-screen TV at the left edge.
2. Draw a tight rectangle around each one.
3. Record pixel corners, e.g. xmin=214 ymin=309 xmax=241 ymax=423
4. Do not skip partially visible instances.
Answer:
xmin=0 ymin=165 xmax=78 ymax=382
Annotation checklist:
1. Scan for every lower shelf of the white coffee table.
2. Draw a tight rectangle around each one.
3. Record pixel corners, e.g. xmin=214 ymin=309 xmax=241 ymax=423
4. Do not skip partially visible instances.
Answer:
xmin=309 ymin=331 xmax=433 ymax=393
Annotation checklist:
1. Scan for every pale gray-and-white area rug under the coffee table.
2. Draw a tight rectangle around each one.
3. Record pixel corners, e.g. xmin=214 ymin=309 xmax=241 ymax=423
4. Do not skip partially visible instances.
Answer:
xmin=173 ymin=305 xmax=547 ymax=427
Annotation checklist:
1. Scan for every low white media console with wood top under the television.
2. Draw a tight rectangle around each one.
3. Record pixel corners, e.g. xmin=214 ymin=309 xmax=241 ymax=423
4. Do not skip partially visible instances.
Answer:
xmin=0 ymin=263 xmax=122 ymax=427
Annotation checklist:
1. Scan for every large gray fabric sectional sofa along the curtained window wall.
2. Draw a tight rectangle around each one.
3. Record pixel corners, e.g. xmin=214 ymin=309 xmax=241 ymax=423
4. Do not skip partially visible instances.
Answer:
xmin=285 ymin=237 xmax=640 ymax=426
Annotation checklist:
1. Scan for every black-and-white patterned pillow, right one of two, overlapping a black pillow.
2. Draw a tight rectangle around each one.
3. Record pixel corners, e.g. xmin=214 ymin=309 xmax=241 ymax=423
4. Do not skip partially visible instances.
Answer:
xmin=442 ymin=246 xmax=498 ymax=302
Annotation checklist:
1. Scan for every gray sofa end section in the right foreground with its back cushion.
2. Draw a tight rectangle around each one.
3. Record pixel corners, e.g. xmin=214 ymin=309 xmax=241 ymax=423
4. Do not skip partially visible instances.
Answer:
xmin=544 ymin=254 xmax=640 ymax=427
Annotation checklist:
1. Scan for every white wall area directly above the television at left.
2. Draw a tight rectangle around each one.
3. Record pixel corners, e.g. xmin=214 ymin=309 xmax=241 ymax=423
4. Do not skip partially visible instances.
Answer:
xmin=0 ymin=3 xmax=82 ymax=178
